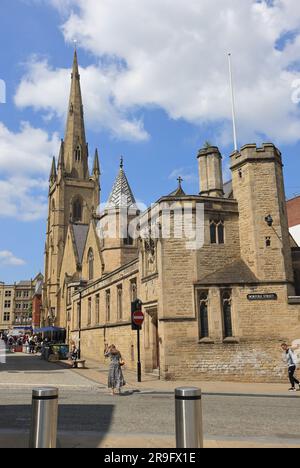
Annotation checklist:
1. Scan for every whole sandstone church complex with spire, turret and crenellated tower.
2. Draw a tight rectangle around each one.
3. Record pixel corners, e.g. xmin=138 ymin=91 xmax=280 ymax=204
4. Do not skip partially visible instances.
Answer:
xmin=42 ymin=53 xmax=300 ymax=382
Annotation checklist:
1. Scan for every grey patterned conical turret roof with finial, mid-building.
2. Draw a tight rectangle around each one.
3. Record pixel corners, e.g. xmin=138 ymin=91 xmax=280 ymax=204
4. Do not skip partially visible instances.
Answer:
xmin=108 ymin=157 xmax=136 ymax=208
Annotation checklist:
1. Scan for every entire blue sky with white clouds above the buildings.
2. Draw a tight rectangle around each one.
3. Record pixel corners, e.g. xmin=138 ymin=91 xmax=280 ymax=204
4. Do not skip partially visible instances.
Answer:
xmin=0 ymin=0 xmax=300 ymax=282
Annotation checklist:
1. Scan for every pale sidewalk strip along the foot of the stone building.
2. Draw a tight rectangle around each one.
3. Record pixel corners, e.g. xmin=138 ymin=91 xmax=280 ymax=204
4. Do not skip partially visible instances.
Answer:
xmin=60 ymin=360 xmax=300 ymax=398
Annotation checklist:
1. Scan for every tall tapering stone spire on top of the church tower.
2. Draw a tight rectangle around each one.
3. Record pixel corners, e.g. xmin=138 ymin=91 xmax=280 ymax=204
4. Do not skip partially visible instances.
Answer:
xmin=64 ymin=50 xmax=89 ymax=179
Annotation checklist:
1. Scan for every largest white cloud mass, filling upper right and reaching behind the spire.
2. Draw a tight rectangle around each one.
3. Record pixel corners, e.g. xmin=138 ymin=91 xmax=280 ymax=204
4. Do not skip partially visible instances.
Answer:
xmin=20 ymin=0 xmax=300 ymax=143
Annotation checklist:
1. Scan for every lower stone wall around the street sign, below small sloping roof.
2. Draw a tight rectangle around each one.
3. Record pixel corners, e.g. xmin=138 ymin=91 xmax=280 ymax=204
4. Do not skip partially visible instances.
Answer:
xmin=160 ymin=285 xmax=300 ymax=382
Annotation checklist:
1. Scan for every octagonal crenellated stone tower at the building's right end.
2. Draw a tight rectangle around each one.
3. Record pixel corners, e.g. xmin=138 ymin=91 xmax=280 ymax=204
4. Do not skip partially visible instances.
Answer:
xmin=231 ymin=143 xmax=294 ymax=295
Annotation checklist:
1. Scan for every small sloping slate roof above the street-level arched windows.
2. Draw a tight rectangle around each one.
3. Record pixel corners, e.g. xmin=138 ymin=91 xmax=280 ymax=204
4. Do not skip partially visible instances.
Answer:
xmin=198 ymin=260 xmax=258 ymax=285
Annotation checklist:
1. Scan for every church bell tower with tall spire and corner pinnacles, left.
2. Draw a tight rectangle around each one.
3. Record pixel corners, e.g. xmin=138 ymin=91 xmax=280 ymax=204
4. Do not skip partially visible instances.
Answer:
xmin=43 ymin=51 xmax=100 ymax=324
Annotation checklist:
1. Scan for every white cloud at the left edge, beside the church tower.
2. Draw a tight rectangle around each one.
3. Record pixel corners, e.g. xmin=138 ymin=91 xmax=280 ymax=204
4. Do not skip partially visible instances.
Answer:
xmin=0 ymin=122 xmax=59 ymax=221
